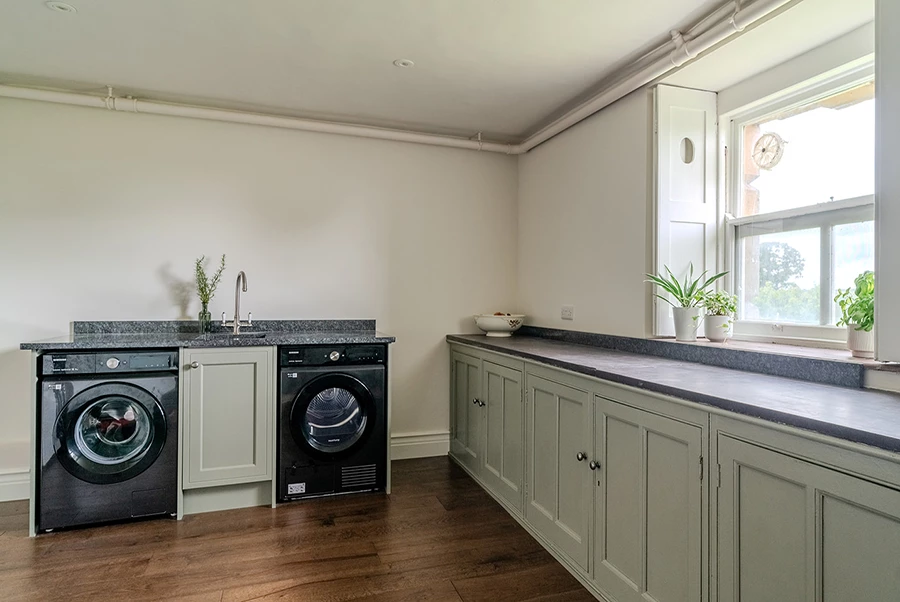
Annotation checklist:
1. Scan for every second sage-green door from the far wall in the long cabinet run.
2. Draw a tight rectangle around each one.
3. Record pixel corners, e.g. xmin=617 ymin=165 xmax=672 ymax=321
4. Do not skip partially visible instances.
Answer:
xmin=481 ymin=360 xmax=525 ymax=510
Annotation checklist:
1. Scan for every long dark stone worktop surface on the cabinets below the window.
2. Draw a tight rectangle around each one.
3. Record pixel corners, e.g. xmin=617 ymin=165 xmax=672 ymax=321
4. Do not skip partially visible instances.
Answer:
xmin=447 ymin=335 xmax=900 ymax=452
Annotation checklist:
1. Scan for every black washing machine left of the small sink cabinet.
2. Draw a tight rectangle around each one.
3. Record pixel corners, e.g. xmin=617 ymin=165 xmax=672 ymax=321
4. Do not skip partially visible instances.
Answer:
xmin=36 ymin=350 xmax=178 ymax=532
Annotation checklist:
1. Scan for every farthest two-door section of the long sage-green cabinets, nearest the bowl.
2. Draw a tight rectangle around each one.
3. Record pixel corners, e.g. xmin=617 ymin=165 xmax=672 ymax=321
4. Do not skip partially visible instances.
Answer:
xmin=450 ymin=351 xmax=525 ymax=512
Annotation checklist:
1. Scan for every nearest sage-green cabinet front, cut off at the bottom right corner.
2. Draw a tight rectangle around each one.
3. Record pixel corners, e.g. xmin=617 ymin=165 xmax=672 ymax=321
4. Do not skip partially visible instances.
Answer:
xmin=718 ymin=434 xmax=900 ymax=602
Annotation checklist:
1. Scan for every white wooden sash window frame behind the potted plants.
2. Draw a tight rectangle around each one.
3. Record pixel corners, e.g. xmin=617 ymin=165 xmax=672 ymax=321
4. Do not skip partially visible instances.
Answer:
xmin=719 ymin=61 xmax=875 ymax=348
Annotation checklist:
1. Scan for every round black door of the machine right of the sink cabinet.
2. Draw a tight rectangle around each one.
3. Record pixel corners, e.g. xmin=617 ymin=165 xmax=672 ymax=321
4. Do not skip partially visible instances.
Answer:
xmin=290 ymin=373 xmax=376 ymax=460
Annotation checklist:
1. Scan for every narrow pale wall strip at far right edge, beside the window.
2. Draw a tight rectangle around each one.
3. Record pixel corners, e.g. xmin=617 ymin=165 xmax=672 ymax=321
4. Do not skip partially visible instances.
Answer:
xmin=875 ymin=0 xmax=900 ymax=362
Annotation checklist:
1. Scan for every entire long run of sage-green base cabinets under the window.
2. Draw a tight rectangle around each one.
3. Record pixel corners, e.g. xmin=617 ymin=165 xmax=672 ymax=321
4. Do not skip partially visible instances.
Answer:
xmin=450 ymin=345 xmax=900 ymax=602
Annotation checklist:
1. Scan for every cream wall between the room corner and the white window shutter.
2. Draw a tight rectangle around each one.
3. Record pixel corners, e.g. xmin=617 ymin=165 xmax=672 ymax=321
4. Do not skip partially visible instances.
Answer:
xmin=519 ymin=90 xmax=653 ymax=337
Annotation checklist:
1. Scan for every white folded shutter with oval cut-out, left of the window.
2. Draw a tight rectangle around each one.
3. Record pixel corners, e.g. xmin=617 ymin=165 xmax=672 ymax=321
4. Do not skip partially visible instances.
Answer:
xmin=653 ymin=85 xmax=717 ymax=336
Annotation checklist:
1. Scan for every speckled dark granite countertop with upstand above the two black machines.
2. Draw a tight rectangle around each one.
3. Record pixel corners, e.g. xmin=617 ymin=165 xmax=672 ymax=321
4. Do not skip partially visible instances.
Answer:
xmin=20 ymin=320 xmax=395 ymax=351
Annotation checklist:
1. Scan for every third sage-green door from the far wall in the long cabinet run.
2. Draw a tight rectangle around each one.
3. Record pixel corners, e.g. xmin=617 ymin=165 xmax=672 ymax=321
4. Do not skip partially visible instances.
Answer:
xmin=525 ymin=375 xmax=591 ymax=570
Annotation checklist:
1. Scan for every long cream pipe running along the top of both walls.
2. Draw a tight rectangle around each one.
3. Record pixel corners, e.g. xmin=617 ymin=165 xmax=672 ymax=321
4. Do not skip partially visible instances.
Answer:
xmin=0 ymin=0 xmax=793 ymax=155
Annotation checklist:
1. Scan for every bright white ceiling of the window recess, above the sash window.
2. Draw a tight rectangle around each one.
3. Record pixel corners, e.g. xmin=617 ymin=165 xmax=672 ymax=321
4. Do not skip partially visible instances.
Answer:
xmin=664 ymin=0 xmax=875 ymax=92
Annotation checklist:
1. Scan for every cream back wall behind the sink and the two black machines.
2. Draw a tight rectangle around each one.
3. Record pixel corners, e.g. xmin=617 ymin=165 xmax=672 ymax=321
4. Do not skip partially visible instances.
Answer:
xmin=0 ymin=100 xmax=517 ymax=478
